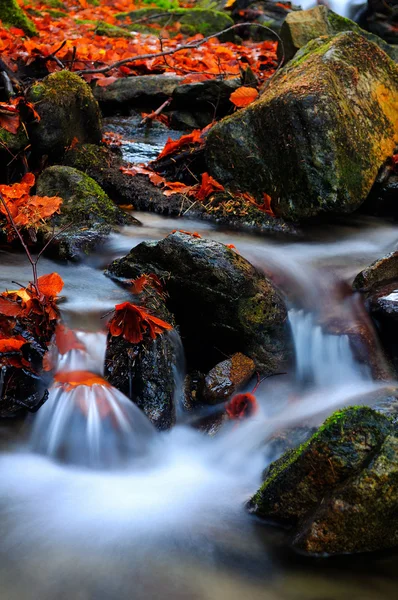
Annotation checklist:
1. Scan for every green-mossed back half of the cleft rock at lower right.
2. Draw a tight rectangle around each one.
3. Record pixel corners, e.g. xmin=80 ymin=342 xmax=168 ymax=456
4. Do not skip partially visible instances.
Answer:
xmin=249 ymin=407 xmax=394 ymax=525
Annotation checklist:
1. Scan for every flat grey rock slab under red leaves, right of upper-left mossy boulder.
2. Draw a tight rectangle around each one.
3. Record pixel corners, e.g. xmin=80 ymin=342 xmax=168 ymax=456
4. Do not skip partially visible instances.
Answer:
xmin=94 ymin=74 xmax=183 ymax=114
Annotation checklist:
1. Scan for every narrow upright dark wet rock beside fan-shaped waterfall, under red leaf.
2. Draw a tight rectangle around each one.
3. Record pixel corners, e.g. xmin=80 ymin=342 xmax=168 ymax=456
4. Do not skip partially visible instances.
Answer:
xmin=105 ymin=288 xmax=179 ymax=431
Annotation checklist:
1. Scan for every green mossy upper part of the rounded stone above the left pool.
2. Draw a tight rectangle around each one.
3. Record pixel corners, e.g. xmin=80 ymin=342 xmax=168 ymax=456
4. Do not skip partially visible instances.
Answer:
xmin=37 ymin=165 xmax=135 ymax=228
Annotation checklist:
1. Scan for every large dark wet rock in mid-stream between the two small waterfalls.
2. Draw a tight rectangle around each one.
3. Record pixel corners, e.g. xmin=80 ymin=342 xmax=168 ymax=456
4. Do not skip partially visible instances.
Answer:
xmin=108 ymin=233 xmax=290 ymax=373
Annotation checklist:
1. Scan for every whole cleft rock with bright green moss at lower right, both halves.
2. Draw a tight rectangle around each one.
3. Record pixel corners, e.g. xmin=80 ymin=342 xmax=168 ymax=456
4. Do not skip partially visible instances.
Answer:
xmin=249 ymin=407 xmax=398 ymax=554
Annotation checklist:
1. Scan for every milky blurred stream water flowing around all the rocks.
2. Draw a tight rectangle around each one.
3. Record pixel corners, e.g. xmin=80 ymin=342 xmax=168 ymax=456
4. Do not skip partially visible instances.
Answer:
xmin=0 ymin=116 xmax=398 ymax=600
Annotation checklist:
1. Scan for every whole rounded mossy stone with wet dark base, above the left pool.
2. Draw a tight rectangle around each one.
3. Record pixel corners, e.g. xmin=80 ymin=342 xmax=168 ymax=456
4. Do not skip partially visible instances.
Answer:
xmin=37 ymin=165 xmax=139 ymax=260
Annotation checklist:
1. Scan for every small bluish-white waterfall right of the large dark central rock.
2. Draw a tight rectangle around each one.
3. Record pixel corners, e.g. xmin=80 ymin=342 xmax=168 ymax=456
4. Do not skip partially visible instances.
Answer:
xmin=289 ymin=309 xmax=371 ymax=388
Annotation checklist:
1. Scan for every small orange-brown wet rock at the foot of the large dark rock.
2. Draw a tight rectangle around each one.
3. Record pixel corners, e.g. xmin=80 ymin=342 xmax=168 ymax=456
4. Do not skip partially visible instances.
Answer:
xmin=203 ymin=352 xmax=256 ymax=404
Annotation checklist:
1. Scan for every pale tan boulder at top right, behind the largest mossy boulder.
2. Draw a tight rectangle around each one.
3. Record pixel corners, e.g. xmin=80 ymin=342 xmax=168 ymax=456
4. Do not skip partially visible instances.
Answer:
xmin=278 ymin=5 xmax=398 ymax=62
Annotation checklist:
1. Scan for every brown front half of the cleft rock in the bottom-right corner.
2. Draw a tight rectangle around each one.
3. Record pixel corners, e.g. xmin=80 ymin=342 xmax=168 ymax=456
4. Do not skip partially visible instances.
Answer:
xmin=293 ymin=434 xmax=398 ymax=555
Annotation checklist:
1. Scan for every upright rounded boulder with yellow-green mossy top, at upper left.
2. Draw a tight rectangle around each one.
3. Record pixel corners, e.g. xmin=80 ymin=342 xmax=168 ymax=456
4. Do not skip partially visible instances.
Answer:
xmin=28 ymin=71 xmax=102 ymax=161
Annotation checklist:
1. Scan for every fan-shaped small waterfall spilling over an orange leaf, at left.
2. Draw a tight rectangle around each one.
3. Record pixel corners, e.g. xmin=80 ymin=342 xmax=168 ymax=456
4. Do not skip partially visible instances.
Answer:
xmin=31 ymin=332 xmax=155 ymax=469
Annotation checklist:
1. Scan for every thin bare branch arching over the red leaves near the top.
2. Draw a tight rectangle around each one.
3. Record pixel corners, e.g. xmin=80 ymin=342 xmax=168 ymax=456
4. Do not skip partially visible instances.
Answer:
xmin=76 ymin=23 xmax=285 ymax=75
